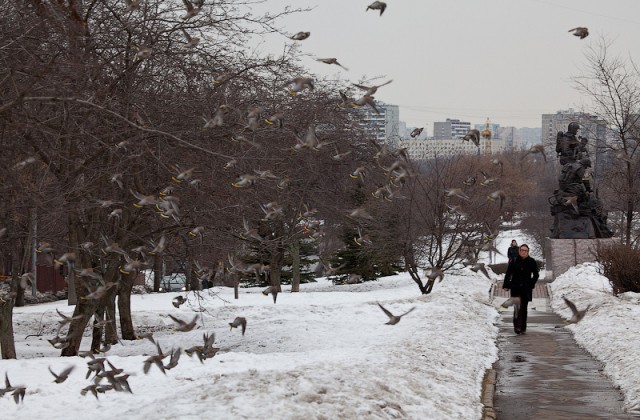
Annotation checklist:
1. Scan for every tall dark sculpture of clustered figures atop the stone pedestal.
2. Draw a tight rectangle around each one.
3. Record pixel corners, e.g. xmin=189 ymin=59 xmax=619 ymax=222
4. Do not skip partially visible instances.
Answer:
xmin=549 ymin=122 xmax=613 ymax=239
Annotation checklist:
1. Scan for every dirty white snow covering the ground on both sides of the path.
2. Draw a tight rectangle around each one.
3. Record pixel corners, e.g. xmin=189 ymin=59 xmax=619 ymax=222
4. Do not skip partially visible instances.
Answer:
xmin=0 ymin=230 xmax=640 ymax=420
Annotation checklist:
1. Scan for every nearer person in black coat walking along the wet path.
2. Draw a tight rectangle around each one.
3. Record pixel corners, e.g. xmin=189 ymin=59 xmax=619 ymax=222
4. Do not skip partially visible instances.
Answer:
xmin=502 ymin=244 xmax=540 ymax=334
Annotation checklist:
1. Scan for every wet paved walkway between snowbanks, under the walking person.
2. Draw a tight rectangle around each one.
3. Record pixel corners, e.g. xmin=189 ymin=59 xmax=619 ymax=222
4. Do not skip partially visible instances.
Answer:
xmin=485 ymin=283 xmax=637 ymax=420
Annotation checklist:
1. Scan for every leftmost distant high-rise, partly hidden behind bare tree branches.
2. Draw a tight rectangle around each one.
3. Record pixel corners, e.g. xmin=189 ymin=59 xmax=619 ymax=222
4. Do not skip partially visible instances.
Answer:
xmin=360 ymin=101 xmax=400 ymax=148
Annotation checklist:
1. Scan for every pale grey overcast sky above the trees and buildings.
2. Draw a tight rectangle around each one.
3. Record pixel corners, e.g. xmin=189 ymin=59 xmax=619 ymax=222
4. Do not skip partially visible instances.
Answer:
xmin=249 ymin=0 xmax=640 ymax=135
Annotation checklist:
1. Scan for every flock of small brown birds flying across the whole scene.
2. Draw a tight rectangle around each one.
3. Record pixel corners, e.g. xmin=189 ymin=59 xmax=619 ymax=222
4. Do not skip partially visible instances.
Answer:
xmin=0 ymin=0 xmax=589 ymax=403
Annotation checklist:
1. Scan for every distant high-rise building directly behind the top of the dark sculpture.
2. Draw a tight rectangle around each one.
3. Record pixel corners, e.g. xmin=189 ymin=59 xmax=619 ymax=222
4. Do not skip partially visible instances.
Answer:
xmin=542 ymin=108 xmax=607 ymax=182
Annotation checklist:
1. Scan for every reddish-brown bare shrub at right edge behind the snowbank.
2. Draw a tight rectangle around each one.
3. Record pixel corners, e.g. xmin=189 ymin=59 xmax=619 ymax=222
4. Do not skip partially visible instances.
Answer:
xmin=597 ymin=244 xmax=640 ymax=295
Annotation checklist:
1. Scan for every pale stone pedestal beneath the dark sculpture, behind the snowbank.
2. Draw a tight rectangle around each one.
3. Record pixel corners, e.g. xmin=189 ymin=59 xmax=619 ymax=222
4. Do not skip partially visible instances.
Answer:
xmin=544 ymin=238 xmax=617 ymax=280
